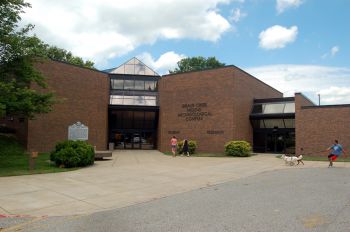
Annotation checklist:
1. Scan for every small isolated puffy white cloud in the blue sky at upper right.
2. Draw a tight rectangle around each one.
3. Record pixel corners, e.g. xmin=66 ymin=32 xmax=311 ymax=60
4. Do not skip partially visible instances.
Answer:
xmin=259 ymin=25 xmax=298 ymax=50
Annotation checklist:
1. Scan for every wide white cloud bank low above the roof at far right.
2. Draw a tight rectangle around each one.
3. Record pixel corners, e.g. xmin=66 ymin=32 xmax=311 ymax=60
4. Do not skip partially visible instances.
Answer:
xmin=245 ymin=64 xmax=350 ymax=104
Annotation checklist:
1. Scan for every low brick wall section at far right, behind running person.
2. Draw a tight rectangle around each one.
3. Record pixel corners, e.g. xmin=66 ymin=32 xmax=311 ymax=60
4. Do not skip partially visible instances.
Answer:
xmin=295 ymin=94 xmax=350 ymax=156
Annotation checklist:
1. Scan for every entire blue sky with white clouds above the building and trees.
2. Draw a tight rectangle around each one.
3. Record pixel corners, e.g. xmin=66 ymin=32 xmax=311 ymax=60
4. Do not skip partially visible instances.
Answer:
xmin=21 ymin=0 xmax=350 ymax=105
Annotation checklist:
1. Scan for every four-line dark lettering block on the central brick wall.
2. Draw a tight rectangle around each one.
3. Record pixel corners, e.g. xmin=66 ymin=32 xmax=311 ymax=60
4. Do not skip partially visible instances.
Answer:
xmin=177 ymin=103 xmax=212 ymax=121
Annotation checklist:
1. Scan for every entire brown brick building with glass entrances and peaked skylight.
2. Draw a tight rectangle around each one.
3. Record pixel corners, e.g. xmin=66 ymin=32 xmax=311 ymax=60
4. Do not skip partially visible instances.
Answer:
xmin=0 ymin=58 xmax=350 ymax=154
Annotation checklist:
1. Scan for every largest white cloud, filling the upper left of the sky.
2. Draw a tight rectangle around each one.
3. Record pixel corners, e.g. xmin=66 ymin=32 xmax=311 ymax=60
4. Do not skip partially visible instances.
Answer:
xmin=22 ymin=0 xmax=231 ymax=62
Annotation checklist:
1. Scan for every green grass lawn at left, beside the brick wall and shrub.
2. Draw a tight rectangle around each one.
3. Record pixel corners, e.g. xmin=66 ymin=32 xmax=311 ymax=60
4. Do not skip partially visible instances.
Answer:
xmin=0 ymin=135 xmax=78 ymax=177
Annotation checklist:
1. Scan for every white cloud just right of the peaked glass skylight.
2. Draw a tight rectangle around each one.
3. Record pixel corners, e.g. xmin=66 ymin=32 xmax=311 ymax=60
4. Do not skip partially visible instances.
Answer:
xmin=137 ymin=51 xmax=186 ymax=75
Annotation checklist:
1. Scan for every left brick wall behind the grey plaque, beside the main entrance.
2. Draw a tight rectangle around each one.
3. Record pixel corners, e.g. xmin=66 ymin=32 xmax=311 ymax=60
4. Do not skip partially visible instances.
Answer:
xmin=27 ymin=61 xmax=109 ymax=151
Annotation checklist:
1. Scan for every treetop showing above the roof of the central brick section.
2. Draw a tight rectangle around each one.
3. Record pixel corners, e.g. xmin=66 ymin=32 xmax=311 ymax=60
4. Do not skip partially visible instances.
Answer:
xmin=169 ymin=56 xmax=225 ymax=73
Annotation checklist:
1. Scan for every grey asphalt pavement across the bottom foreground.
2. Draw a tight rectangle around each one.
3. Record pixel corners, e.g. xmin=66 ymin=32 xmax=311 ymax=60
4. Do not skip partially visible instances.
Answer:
xmin=1 ymin=168 xmax=350 ymax=232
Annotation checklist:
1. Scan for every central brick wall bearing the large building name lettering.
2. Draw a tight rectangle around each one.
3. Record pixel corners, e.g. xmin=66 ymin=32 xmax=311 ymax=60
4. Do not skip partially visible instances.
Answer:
xmin=158 ymin=66 xmax=281 ymax=152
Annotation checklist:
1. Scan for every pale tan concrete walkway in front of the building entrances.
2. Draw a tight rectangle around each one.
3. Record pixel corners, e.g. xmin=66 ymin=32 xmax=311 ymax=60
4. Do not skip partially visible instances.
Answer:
xmin=0 ymin=150 xmax=344 ymax=216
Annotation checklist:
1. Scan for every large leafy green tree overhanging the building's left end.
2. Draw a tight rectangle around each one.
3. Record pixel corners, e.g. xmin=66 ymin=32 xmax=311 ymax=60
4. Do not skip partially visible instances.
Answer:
xmin=0 ymin=0 xmax=93 ymax=119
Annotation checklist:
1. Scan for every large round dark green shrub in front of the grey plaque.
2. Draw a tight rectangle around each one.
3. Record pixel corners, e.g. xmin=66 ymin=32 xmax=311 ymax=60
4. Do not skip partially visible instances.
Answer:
xmin=50 ymin=140 xmax=95 ymax=168
